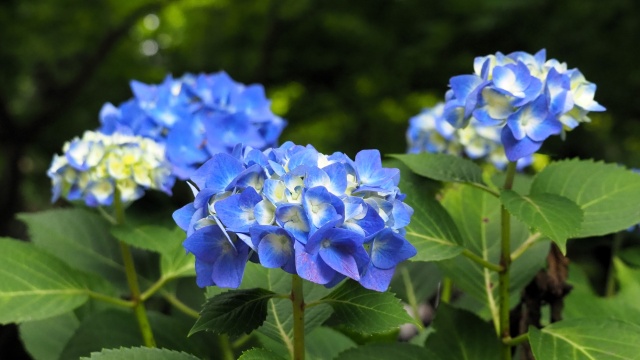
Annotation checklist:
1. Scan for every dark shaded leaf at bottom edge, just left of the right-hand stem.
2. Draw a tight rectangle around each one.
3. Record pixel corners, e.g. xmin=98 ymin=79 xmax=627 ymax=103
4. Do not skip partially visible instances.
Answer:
xmin=425 ymin=304 xmax=500 ymax=360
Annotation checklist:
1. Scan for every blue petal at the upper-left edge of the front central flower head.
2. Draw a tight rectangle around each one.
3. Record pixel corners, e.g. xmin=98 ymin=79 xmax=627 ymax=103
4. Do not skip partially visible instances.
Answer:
xmin=191 ymin=153 xmax=244 ymax=193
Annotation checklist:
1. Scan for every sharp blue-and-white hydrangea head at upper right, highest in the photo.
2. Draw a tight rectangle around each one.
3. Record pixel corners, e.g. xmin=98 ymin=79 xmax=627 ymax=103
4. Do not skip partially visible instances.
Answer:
xmin=444 ymin=49 xmax=605 ymax=161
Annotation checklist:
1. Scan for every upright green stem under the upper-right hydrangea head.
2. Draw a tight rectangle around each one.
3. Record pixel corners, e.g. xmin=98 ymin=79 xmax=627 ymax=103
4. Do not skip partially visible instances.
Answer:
xmin=498 ymin=161 xmax=516 ymax=360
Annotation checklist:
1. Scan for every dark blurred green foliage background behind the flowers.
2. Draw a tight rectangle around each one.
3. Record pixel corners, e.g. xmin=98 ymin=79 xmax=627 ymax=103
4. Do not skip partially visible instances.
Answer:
xmin=0 ymin=0 xmax=640 ymax=354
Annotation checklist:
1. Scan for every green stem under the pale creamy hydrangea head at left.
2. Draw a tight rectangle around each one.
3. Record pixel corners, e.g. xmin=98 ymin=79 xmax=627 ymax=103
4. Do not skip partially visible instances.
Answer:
xmin=114 ymin=187 xmax=156 ymax=347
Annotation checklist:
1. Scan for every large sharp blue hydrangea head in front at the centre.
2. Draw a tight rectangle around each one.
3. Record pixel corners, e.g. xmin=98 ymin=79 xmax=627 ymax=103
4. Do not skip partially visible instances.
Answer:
xmin=173 ymin=142 xmax=416 ymax=291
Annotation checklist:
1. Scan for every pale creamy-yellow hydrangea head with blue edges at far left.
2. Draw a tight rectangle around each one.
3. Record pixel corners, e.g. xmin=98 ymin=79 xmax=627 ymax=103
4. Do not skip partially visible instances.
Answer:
xmin=47 ymin=131 xmax=175 ymax=207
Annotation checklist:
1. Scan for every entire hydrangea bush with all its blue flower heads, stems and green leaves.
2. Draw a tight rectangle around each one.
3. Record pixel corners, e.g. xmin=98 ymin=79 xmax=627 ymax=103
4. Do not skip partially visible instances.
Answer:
xmin=0 ymin=51 xmax=640 ymax=360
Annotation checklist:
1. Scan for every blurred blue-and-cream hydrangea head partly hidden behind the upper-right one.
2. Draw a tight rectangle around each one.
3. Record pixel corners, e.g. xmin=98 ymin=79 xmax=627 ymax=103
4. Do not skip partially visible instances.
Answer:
xmin=406 ymin=102 xmax=533 ymax=169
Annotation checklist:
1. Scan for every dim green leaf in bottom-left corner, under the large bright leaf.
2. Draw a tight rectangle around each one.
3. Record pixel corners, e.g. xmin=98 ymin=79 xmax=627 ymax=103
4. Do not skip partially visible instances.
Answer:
xmin=19 ymin=312 xmax=80 ymax=360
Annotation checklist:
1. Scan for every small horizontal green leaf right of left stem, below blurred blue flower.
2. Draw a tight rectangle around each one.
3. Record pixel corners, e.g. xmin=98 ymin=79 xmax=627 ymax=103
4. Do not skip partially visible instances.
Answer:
xmin=111 ymin=223 xmax=186 ymax=254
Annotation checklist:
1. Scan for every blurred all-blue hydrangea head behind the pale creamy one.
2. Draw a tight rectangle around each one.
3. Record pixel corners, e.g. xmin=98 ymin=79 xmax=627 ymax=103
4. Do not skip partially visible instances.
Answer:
xmin=100 ymin=71 xmax=286 ymax=180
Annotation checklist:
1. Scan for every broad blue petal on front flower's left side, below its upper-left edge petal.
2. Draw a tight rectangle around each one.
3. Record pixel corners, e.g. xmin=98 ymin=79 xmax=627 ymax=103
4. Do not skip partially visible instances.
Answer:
xmin=214 ymin=187 xmax=262 ymax=232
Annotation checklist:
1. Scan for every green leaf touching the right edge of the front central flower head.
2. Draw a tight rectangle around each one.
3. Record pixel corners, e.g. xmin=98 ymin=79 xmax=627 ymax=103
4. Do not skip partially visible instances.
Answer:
xmin=406 ymin=195 xmax=463 ymax=261
